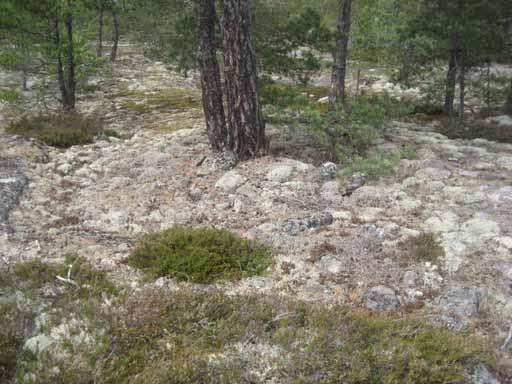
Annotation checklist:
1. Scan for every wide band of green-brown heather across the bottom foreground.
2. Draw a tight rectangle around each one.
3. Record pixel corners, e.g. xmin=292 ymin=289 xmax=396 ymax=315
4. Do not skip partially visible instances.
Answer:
xmin=0 ymin=258 xmax=493 ymax=384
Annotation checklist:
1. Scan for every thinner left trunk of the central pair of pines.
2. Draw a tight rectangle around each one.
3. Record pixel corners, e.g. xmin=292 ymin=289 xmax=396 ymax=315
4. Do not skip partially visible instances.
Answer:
xmin=198 ymin=0 xmax=228 ymax=151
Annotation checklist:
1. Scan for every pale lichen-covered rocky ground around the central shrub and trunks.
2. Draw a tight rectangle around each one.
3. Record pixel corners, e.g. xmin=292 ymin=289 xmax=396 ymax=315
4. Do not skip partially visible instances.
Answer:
xmin=0 ymin=43 xmax=512 ymax=382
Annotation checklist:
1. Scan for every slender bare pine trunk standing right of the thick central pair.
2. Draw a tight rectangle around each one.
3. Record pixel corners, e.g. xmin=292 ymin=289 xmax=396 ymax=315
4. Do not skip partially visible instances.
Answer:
xmin=329 ymin=0 xmax=352 ymax=110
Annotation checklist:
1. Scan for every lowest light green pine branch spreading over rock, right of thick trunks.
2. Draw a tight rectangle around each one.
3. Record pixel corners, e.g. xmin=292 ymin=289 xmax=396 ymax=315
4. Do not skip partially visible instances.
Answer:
xmin=338 ymin=149 xmax=416 ymax=184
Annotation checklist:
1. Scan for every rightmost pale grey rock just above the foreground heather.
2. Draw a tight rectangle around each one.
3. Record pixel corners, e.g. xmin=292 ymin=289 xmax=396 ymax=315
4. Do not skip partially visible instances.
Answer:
xmin=438 ymin=287 xmax=482 ymax=317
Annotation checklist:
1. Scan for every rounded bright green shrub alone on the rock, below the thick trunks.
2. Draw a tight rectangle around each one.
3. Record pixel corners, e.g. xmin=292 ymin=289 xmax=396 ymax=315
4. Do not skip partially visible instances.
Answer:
xmin=129 ymin=227 xmax=271 ymax=283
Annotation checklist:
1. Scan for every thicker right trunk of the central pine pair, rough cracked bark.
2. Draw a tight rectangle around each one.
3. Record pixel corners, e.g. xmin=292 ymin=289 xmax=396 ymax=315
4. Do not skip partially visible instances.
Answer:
xmin=222 ymin=0 xmax=267 ymax=160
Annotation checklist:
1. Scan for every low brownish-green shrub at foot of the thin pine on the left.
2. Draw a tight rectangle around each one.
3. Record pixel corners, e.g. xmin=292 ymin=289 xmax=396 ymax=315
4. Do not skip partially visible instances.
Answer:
xmin=6 ymin=114 xmax=102 ymax=148
